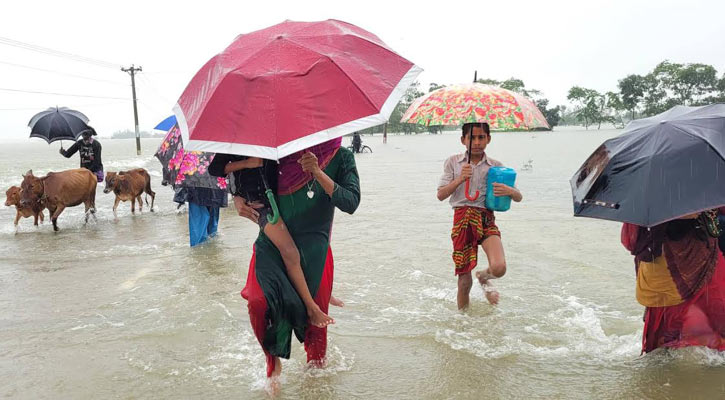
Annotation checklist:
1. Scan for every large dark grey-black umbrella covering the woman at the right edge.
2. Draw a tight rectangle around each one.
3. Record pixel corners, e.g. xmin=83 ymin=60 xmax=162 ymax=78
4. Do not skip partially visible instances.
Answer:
xmin=571 ymin=104 xmax=725 ymax=227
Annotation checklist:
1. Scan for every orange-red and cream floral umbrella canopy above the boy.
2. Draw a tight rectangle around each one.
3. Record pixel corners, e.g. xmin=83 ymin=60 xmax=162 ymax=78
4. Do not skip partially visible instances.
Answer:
xmin=400 ymin=83 xmax=549 ymax=130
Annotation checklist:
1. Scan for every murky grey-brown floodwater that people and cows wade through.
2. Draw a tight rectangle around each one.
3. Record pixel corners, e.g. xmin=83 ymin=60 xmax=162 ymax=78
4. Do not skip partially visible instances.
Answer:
xmin=0 ymin=129 xmax=725 ymax=399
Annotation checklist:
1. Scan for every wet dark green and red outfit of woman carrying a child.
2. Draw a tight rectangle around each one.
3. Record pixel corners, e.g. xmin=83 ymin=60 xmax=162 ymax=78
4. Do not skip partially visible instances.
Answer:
xmin=242 ymin=145 xmax=360 ymax=375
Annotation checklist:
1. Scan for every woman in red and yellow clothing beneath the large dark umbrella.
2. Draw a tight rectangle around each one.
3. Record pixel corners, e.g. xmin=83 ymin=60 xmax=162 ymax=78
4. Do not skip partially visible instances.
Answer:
xmin=622 ymin=211 xmax=725 ymax=353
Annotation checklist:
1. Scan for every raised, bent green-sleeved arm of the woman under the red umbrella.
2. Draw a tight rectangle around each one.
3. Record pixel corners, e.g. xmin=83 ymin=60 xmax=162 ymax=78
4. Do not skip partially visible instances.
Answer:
xmin=299 ymin=150 xmax=360 ymax=214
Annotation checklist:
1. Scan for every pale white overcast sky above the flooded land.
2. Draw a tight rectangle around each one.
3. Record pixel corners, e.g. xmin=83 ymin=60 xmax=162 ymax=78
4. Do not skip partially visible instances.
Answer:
xmin=0 ymin=0 xmax=725 ymax=140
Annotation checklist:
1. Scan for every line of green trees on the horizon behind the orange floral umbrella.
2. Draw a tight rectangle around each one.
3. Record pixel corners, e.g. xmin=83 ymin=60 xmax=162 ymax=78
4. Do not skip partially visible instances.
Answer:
xmin=361 ymin=60 xmax=725 ymax=135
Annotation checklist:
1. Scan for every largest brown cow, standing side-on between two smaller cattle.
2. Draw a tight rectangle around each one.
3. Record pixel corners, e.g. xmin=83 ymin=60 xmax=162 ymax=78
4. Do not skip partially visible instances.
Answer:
xmin=20 ymin=168 xmax=98 ymax=231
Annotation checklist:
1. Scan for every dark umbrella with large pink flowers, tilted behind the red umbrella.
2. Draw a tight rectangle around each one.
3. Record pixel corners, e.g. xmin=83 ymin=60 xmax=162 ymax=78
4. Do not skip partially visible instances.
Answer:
xmin=155 ymin=126 xmax=227 ymax=189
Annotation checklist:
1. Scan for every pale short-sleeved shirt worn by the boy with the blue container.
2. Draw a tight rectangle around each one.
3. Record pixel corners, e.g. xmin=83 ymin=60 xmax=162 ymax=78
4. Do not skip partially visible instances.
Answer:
xmin=438 ymin=152 xmax=503 ymax=208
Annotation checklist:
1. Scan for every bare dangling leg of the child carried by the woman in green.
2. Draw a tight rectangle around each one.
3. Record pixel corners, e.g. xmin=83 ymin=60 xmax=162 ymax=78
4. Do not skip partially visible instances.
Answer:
xmin=264 ymin=219 xmax=335 ymax=328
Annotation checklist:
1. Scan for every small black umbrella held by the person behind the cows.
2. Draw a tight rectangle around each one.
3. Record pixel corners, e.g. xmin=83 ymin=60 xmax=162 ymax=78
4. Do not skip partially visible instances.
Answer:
xmin=28 ymin=107 xmax=90 ymax=144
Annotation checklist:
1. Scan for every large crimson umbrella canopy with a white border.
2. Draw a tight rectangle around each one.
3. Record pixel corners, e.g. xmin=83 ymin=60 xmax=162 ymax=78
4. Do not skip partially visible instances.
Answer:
xmin=174 ymin=20 xmax=422 ymax=160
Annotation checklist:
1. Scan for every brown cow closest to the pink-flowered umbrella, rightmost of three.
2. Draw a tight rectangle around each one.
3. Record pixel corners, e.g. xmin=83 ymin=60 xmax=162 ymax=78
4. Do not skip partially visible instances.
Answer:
xmin=103 ymin=168 xmax=156 ymax=218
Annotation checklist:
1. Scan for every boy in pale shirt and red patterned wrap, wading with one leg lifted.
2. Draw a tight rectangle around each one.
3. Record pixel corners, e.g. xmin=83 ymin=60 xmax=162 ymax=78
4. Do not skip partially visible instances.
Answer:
xmin=438 ymin=122 xmax=522 ymax=310
